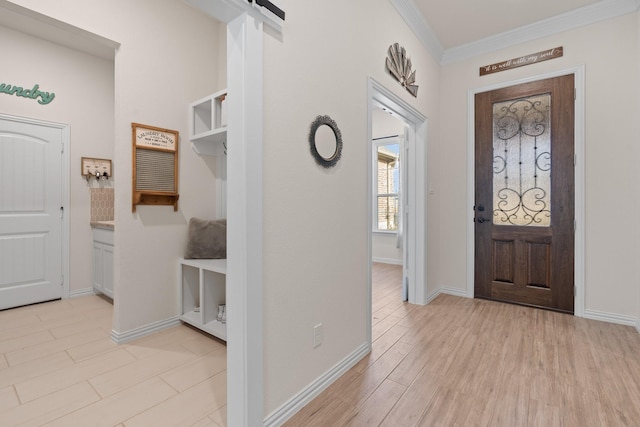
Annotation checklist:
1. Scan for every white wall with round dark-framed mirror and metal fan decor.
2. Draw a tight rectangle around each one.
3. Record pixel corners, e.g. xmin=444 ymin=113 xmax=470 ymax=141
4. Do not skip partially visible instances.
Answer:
xmin=263 ymin=0 xmax=439 ymax=415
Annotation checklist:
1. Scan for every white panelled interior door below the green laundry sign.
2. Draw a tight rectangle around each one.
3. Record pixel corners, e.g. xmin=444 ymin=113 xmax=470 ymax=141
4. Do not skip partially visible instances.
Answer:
xmin=0 ymin=116 xmax=64 ymax=309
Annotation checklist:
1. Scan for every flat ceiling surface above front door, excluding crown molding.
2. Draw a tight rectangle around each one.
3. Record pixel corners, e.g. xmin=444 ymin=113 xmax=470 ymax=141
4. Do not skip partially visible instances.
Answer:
xmin=414 ymin=0 xmax=602 ymax=49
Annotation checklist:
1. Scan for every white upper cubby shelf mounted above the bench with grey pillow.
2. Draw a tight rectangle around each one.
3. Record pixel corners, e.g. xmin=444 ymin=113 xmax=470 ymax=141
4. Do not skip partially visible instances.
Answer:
xmin=190 ymin=89 xmax=227 ymax=156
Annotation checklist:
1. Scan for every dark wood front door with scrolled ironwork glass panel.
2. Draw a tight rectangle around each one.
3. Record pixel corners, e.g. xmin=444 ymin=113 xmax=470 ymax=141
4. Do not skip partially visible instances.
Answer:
xmin=474 ymin=75 xmax=575 ymax=313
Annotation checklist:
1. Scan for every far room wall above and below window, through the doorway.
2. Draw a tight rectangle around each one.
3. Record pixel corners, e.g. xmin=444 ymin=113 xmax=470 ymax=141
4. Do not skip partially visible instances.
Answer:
xmin=371 ymin=108 xmax=404 ymax=264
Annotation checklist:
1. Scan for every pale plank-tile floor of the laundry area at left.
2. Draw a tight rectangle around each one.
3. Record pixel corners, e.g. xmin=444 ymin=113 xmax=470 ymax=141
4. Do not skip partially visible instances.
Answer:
xmin=0 ymin=296 xmax=227 ymax=427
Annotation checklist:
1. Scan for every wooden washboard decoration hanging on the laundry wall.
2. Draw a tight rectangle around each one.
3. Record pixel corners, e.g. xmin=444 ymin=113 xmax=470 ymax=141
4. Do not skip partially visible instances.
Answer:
xmin=131 ymin=123 xmax=179 ymax=212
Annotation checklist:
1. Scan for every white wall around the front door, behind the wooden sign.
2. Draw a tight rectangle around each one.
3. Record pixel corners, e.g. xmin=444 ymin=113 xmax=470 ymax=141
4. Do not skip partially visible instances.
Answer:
xmin=440 ymin=14 xmax=640 ymax=319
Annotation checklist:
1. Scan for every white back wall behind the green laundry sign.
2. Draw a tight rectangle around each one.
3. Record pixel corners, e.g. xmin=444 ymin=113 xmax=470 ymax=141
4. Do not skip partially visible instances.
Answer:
xmin=0 ymin=26 xmax=113 ymax=293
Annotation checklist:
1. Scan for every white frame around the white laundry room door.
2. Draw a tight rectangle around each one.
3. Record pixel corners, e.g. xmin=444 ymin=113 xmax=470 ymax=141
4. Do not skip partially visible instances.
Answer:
xmin=0 ymin=113 xmax=71 ymax=299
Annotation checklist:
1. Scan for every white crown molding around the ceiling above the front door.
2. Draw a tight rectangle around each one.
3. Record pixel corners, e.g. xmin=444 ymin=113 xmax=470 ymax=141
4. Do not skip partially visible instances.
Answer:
xmin=389 ymin=0 xmax=640 ymax=65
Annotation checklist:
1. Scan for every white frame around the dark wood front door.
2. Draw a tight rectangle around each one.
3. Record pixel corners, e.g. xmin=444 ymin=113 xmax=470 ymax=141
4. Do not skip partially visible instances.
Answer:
xmin=467 ymin=65 xmax=585 ymax=317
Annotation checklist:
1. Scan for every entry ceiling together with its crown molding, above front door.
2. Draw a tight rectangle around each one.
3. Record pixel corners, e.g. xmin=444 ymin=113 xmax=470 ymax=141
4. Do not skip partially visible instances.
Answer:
xmin=398 ymin=0 xmax=640 ymax=64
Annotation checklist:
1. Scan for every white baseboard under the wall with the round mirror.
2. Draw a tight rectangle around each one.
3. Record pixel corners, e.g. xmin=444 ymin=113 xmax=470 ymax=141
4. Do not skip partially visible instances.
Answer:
xmin=263 ymin=343 xmax=371 ymax=427
